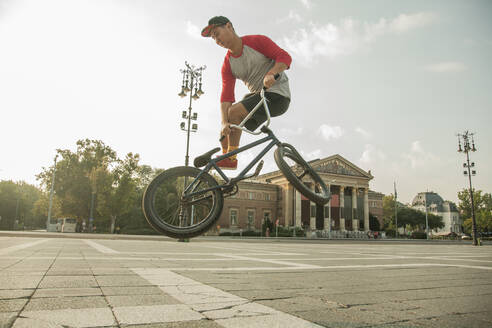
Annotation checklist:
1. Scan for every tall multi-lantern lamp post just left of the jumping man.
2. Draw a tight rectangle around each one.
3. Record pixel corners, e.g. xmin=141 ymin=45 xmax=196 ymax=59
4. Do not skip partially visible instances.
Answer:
xmin=178 ymin=62 xmax=207 ymax=166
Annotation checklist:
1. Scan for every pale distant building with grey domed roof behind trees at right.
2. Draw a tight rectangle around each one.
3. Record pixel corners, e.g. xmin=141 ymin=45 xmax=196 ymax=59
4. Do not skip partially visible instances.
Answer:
xmin=412 ymin=191 xmax=463 ymax=233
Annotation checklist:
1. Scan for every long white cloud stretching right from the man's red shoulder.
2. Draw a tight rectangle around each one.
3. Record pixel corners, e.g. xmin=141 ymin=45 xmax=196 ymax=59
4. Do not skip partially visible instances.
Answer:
xmin=282 ymin=12 xmax=437 ymax=65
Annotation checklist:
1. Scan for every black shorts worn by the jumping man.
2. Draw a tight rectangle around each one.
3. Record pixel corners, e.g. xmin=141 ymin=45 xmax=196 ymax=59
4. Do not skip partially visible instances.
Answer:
xmin=240 ymin=92 xmax=290 ymax=131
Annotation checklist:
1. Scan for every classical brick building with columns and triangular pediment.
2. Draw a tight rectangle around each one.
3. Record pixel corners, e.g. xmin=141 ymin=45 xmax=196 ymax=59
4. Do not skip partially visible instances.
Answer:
xmin=217 ymin=154 xmax=373 ymax=233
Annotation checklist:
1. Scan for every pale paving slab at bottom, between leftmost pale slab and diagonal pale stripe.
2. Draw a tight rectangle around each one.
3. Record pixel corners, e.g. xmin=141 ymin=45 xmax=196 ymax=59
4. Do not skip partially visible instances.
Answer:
xmin=113 ymin=304 xmax=203 ymax=325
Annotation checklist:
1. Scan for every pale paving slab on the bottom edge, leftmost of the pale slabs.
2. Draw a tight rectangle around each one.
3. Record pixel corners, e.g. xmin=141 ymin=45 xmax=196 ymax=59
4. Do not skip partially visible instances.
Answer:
xmin=13 ymin=308 xmax=116 ymax=328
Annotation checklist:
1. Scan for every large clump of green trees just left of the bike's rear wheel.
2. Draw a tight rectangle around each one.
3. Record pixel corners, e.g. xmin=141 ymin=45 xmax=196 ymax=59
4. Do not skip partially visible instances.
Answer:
xmin=36 ymin=139 xmax=160 ymax=233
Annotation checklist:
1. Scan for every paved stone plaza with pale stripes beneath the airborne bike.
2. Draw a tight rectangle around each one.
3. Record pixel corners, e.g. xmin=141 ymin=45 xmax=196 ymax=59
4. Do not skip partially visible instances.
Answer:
xmin=0 ymin=234 xmax=492 ymax=328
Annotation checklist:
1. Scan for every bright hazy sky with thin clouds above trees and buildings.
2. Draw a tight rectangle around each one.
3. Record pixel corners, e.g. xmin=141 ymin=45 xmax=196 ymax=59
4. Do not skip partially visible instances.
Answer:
xmin=0 ymin=0 xmax=492 ymax=203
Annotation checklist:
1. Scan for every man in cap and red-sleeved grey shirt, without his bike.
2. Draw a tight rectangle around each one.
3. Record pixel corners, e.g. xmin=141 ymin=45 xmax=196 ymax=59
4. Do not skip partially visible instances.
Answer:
xmin=202 ymin=16 xmax=292 ymax=169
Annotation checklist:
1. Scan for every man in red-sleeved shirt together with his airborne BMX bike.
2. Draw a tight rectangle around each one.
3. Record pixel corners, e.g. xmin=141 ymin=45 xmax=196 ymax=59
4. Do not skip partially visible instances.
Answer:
xmin=142 ymin=16 xmax=330 ymax=238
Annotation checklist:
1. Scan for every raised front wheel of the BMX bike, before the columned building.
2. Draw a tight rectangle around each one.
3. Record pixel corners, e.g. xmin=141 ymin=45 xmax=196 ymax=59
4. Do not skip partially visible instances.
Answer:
xmin=274 ymin=143 xmax=330 ymax=205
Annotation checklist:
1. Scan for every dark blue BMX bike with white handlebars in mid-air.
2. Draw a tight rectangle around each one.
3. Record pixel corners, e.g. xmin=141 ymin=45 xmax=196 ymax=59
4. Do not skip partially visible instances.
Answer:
xmin=142 ymin=79 xmax=330 ymax=239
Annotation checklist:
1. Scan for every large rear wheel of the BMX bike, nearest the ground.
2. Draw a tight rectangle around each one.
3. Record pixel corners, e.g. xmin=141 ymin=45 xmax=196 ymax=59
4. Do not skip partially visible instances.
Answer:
xmin=142 ymin=166 xmax=224 ymax=239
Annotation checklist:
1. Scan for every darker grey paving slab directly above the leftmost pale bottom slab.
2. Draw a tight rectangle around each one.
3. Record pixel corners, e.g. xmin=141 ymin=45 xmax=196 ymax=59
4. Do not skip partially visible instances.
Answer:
xmin=24 ymin=296 xmax=108 ymax=311
